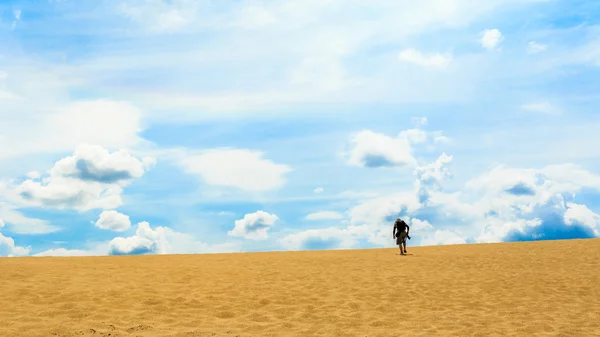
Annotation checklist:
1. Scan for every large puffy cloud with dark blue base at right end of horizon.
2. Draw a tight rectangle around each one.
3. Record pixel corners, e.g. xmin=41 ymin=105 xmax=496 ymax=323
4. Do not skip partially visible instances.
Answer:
xmin=439 ymin=164 xmax=600 ymax=242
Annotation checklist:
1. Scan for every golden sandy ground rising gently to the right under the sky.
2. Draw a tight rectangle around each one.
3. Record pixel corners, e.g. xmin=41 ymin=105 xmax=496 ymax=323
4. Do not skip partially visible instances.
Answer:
xmin=0 ymin=240 xmax=600 ymax=337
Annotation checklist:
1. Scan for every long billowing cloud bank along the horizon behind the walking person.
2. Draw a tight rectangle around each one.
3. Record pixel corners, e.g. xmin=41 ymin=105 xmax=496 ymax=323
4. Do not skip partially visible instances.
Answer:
xmin=281 ymin=146 xmax=600 ymax=249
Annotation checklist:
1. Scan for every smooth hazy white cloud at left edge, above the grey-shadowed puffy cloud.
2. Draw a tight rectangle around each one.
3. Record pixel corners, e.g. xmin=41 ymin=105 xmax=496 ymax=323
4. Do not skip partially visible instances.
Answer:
xmin=0 ymin=100 xmax=143 ymax=159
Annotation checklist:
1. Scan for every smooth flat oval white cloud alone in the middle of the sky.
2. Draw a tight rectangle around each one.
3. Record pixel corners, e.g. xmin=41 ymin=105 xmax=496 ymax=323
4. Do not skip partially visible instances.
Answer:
xmin=179 ymin=149 xmax=291 ymax=192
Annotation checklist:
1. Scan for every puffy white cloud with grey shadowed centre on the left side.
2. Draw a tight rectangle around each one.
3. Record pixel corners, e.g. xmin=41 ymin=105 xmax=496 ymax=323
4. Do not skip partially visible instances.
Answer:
xmin=5 ymin=144 xmax=154 ymax=211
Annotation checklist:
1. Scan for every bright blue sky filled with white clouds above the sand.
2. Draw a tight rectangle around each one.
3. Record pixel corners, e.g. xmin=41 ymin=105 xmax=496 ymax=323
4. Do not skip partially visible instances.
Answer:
xmin=0 ymin=0 xmax=600 ymax=256
